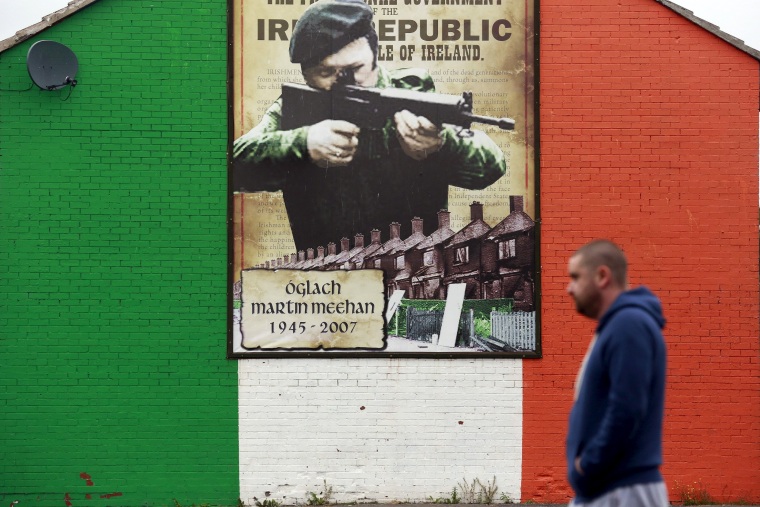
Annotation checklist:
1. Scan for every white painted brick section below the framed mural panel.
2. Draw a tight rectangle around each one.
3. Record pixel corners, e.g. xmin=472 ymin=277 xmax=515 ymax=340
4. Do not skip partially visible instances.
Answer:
xmin=238 ymin=358 xmax=522 ymax=505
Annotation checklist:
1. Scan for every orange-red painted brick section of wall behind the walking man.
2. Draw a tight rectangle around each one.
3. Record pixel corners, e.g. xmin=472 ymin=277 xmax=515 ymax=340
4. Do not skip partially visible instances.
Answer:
xmin=522 ymin=0 xmax=760 ymax=503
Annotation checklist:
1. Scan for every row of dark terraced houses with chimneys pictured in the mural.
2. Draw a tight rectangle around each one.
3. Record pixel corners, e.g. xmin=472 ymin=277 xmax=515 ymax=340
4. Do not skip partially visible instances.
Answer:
xmin=252 ymin=196 xmax=535 ymax=311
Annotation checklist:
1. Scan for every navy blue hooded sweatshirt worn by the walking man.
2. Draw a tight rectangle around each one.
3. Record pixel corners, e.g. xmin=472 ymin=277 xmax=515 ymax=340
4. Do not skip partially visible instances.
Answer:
xmin=567 ymin=287 xmax=665 ymax=502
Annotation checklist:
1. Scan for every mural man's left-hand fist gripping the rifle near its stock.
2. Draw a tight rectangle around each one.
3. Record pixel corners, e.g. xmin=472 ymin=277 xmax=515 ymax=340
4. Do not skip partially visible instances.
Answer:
xmin=306 ymin=120 xmax=359 ymax=168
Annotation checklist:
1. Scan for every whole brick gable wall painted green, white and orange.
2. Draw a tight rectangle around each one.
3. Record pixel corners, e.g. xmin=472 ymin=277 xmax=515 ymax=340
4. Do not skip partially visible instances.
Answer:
xmin=0 ymin=0 xmax=760 ymax=507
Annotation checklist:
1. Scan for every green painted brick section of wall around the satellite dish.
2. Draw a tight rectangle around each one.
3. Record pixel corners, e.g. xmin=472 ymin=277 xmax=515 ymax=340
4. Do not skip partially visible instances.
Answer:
xmin=0 ymin=0 xmax=238 ymax=507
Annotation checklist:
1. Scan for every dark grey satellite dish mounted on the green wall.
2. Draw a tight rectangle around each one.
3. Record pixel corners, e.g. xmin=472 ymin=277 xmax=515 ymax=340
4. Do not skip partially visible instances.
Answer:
xmin=26 ymin=40 xmax=79 ymax=90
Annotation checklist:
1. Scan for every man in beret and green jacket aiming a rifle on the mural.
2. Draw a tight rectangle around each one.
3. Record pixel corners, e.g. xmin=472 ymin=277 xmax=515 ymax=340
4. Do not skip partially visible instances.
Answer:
xmin=233 ymin=0 xmax=506 ymax=254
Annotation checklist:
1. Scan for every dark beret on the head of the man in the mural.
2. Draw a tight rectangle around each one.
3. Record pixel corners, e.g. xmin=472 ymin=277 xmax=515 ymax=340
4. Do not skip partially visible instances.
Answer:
xmin=290 ymin=0 xmax=373 ymax=66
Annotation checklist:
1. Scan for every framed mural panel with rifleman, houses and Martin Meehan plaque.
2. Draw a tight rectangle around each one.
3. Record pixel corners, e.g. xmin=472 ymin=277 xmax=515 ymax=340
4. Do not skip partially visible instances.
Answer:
xmin=227 ymin=0 xmax=541 ymax=358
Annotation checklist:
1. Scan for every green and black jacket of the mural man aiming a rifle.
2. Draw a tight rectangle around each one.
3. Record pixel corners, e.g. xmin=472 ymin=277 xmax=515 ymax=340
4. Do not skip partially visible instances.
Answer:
xmin=232 ymin=67 xmax=506 ymax=254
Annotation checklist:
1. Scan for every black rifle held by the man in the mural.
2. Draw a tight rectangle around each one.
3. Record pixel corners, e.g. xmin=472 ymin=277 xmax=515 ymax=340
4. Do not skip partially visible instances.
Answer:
xmin=281 ymin=79 xmax=515 ymax=135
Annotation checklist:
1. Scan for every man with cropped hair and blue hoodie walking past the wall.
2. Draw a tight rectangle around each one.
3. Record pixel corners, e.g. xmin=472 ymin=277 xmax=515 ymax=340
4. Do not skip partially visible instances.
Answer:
xmin=566 ymin=240 xmax=669 ymax=507
